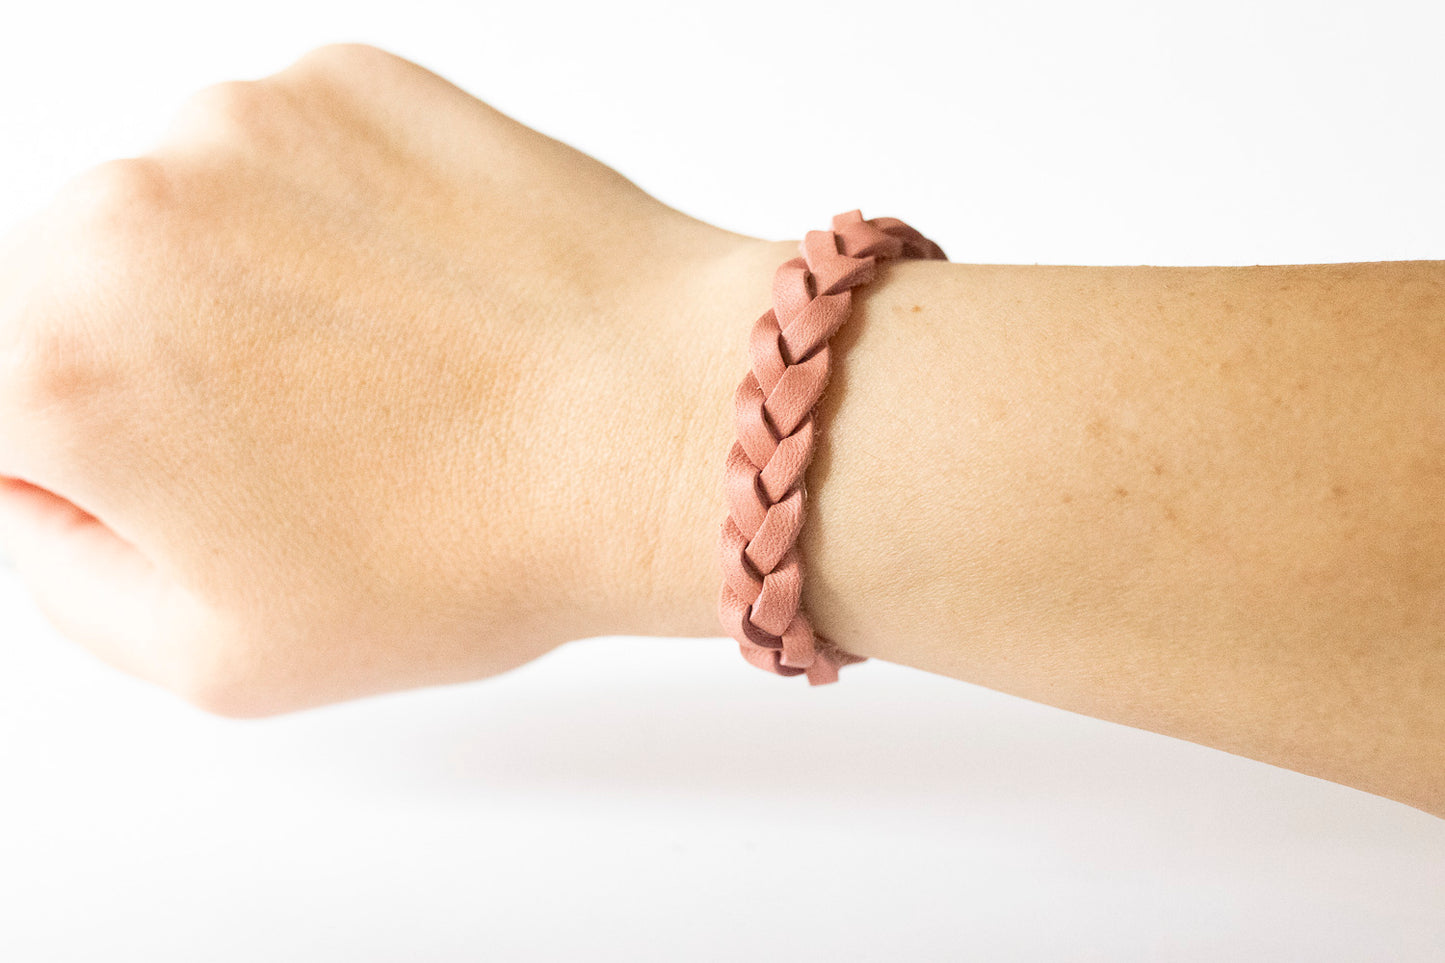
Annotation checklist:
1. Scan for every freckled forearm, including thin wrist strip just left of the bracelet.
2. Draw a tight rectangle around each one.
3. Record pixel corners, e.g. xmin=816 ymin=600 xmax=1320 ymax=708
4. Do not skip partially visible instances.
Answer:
xmin=658 ymin=243 xmax=1445 ymax=816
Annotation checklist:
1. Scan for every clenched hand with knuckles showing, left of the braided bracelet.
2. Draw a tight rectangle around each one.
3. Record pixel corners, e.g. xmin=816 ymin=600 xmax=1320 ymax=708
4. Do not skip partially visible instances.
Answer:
xmin=0 ymin=45 xmax=793 ymax=717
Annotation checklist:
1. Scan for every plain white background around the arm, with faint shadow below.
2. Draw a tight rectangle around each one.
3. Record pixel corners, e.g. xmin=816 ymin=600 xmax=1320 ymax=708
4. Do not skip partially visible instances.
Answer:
xmin=0 ymin=0 xmax=1445 ymax=963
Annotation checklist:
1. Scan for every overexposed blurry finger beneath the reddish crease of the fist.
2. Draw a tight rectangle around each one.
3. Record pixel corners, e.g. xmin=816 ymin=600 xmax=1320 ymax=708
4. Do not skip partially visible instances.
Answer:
xmin=0 ymin=477 xmax=189 ymax=688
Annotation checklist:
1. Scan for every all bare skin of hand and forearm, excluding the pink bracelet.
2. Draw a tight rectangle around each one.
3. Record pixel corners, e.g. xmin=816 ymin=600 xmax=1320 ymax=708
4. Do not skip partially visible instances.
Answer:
xmin=0 ymin=45 xmax=1445 ymax=816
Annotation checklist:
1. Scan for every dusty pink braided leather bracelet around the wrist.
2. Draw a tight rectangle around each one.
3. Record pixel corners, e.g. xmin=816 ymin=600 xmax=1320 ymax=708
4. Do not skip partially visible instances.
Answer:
xmin=718 ymin=210 xmax=948 ymax=685
